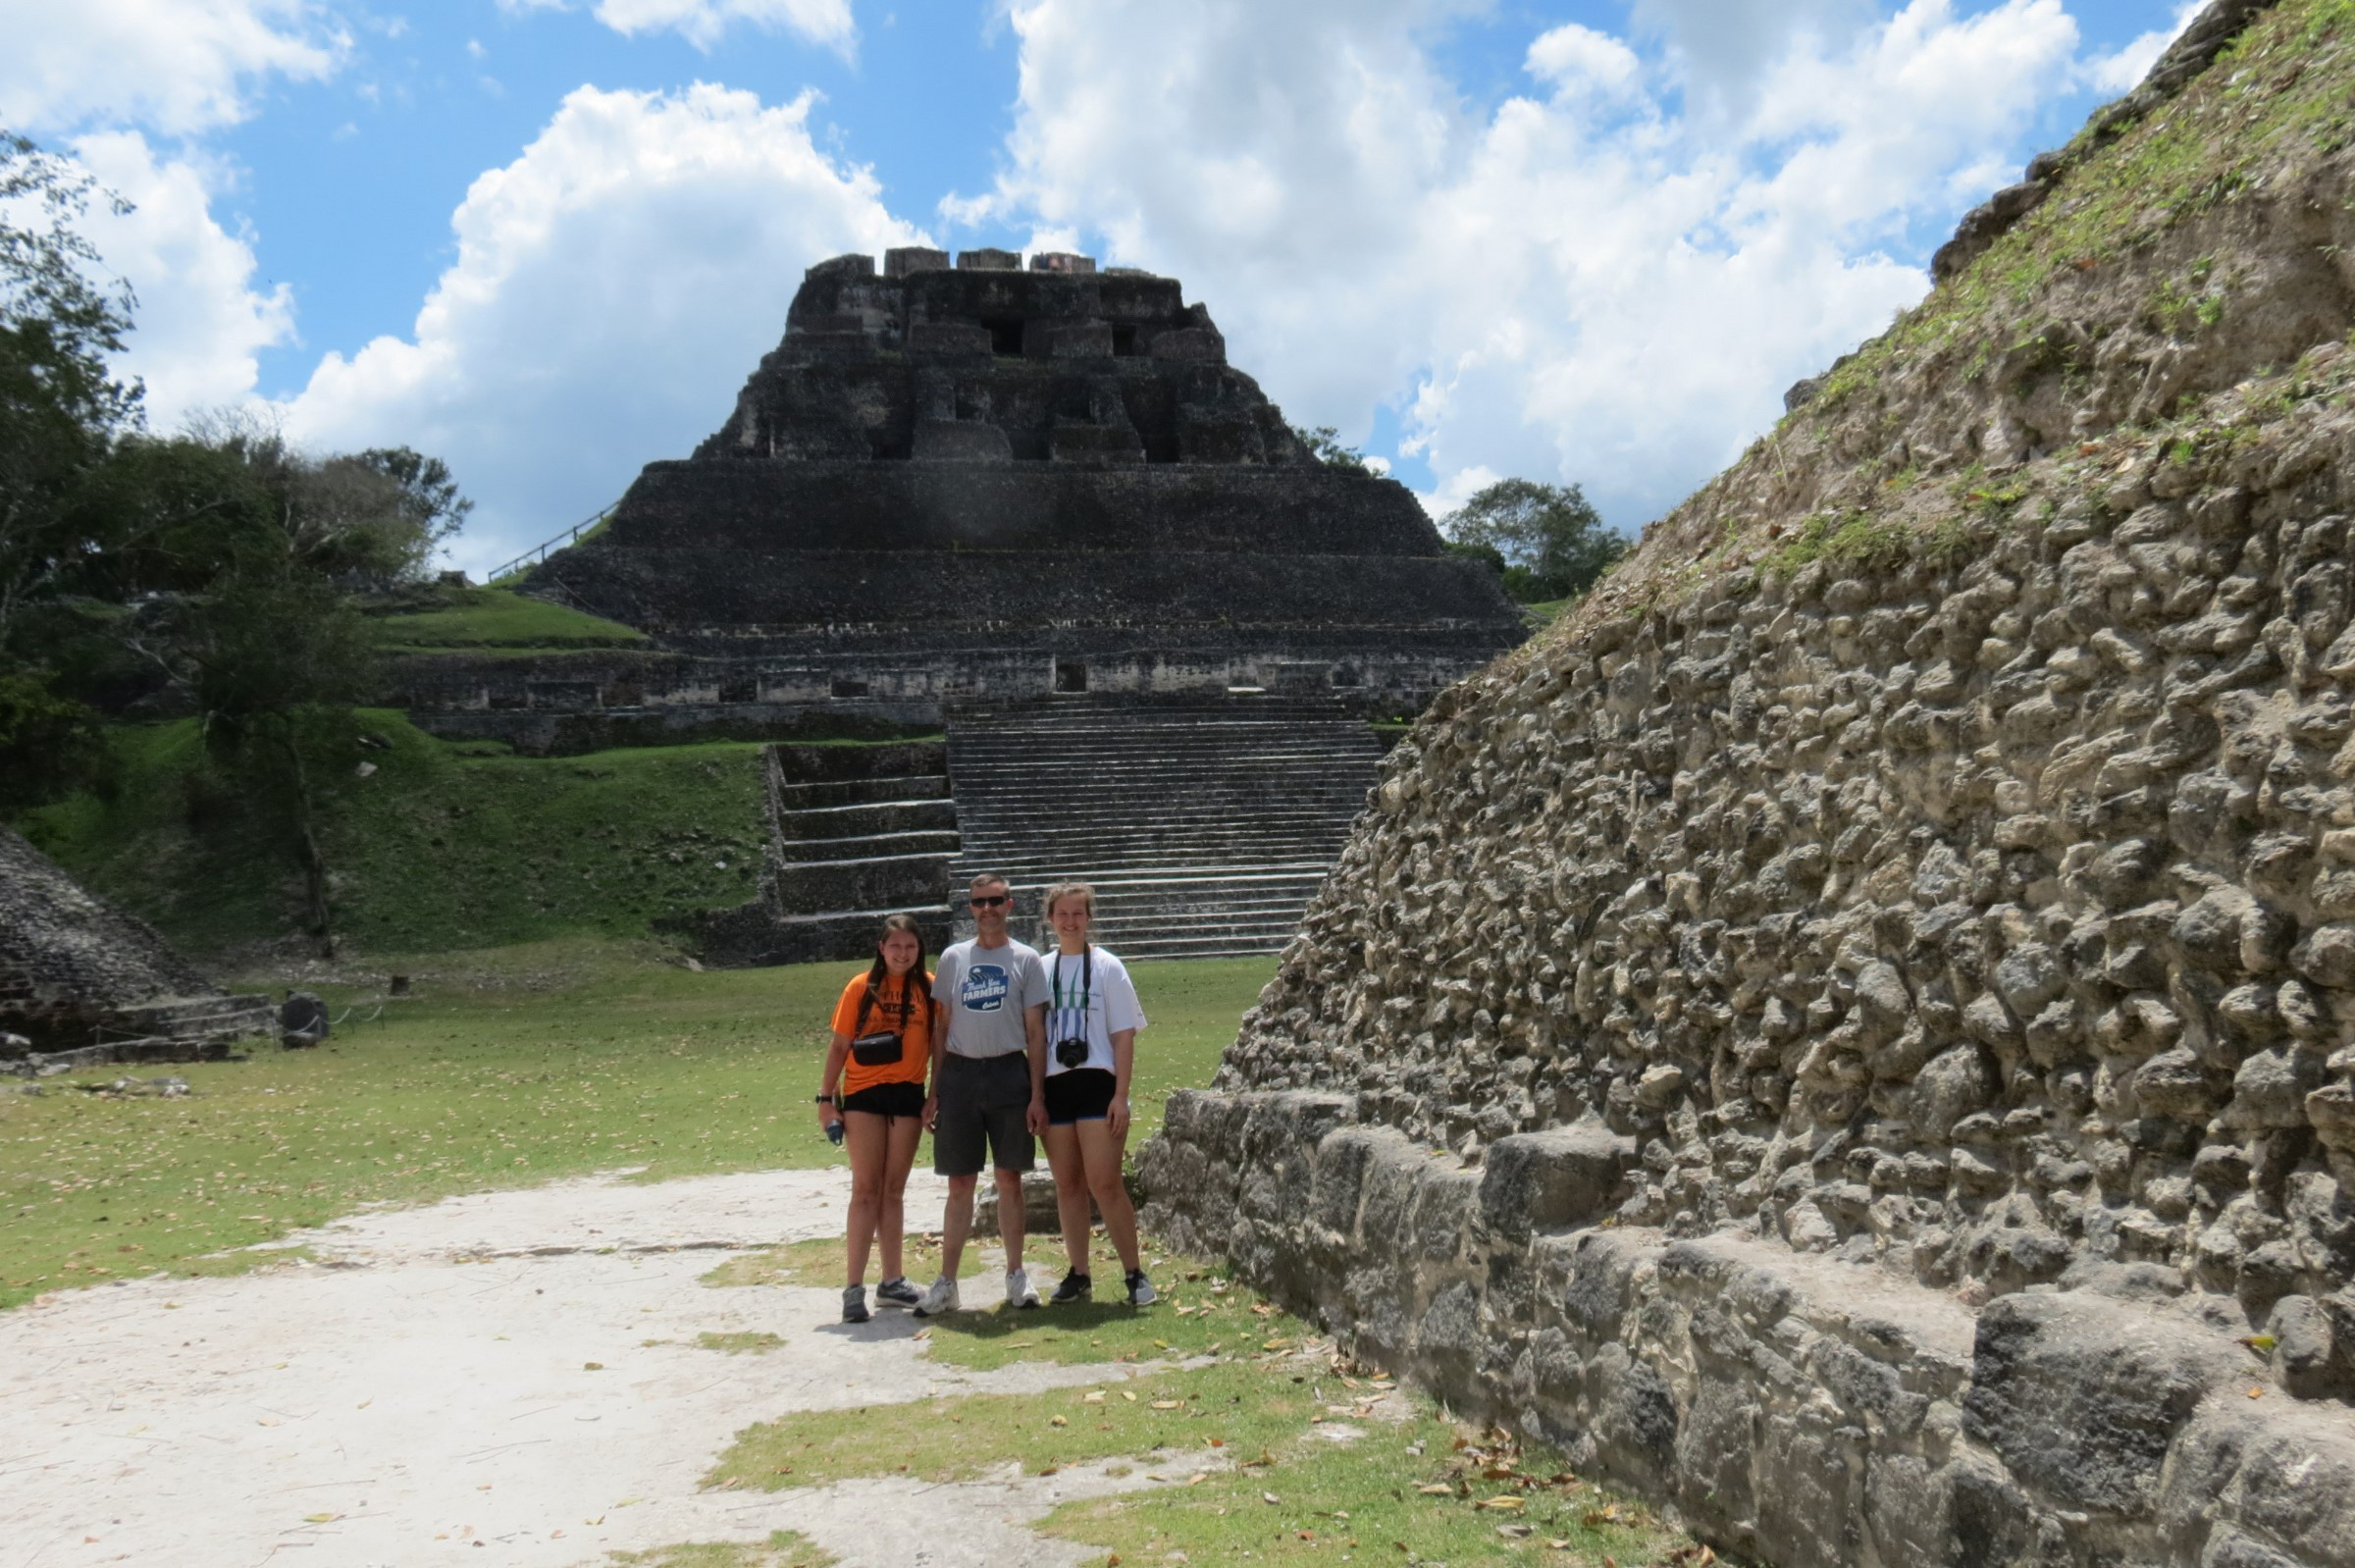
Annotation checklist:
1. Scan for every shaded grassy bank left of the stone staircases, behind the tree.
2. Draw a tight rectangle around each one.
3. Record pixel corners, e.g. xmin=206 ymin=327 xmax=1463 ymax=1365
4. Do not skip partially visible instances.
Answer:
xmin=22 ymin=711 xmax=765 ymax=956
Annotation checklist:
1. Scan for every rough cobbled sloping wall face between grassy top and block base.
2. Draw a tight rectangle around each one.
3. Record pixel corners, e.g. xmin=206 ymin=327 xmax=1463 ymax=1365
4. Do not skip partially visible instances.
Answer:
xmin=1220 ymin=381 xmax=2355 ymax=1328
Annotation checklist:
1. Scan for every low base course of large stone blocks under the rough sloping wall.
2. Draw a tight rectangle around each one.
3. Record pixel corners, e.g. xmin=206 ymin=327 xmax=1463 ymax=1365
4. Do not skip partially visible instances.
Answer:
xmin=1140 ymin=1092 xmax=2355 ymax=1568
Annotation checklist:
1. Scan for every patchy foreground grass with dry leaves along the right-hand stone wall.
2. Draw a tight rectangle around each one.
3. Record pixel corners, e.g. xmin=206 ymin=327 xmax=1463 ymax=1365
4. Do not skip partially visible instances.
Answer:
xmin=705 ymin=1257 xmax=1701 ymax=1568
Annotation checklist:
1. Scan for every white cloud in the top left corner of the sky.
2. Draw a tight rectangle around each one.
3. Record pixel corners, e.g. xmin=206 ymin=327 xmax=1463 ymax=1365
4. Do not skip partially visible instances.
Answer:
xmin=0 ymin=0 xmax=351 ymax=136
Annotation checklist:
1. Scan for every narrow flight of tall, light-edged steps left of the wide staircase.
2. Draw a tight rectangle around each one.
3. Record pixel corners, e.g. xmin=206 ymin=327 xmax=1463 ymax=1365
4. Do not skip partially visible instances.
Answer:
xmin=760 ymin=742 xmax=959 ymax=963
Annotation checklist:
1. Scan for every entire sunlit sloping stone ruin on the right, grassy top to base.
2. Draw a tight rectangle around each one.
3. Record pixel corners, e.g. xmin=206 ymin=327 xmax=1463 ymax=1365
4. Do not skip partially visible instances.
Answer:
xmin=1140 ymin=0 xmax=2355 ymax=1568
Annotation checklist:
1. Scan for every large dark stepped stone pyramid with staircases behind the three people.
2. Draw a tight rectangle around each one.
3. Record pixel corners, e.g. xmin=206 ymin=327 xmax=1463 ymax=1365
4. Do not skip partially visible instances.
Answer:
xmin=402 ymin=249 xmax=1524 ymax=963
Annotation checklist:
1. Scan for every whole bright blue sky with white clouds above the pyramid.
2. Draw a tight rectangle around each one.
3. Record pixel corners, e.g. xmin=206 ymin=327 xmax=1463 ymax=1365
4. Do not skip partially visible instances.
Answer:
xmin=0 ymin=0 xmax=2190 ymax=570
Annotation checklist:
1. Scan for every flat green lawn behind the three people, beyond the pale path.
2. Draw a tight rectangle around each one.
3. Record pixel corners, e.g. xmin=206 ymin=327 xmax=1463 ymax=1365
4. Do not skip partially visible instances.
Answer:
xmin=0 ymin=942 xmax=1274 ymax=1307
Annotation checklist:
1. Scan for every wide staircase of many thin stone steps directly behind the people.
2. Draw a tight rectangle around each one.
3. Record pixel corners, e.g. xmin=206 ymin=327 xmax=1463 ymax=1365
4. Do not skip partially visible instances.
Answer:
xmin=947 ymin=692 xmax=1383 ymax=959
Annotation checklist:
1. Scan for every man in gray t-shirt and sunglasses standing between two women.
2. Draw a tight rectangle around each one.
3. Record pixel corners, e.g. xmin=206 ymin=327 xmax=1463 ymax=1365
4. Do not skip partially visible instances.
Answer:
xmin=916 ymin=876 xmax=1048 ymax=1319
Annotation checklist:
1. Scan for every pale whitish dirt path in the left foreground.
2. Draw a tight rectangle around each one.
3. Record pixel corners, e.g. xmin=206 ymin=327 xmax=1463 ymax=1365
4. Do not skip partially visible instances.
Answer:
xmin=0 ymin=1171 xmax=1182 ymax=1568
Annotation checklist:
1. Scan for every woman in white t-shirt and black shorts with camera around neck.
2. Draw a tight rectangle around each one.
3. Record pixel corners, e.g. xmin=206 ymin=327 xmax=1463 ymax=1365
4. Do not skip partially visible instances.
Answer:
xmin=1046 ymin=883 xmax=1154 ymax=1307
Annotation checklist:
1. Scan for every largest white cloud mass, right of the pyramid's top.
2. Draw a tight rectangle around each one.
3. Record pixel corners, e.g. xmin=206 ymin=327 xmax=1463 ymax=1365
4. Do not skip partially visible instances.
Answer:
xmin=944 ymin=0 xmax=2077 ymax=525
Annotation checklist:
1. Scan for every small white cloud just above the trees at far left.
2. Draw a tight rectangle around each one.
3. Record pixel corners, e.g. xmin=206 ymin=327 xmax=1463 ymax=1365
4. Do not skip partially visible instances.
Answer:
xmin=73 ymin=131 xmax=294 ymax=431
